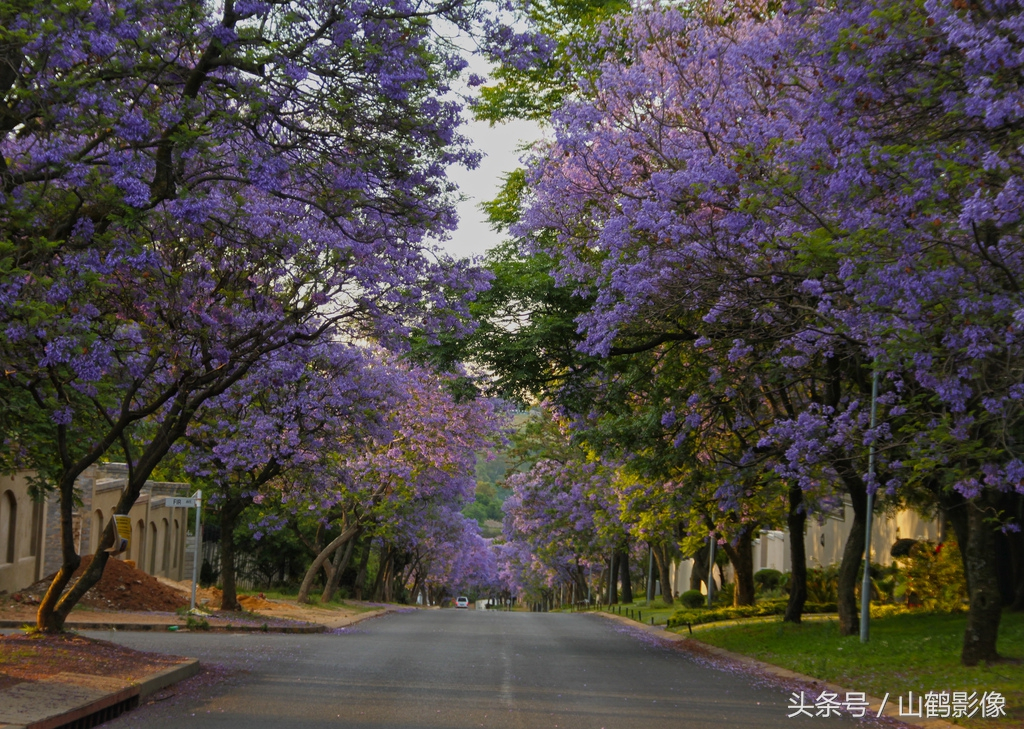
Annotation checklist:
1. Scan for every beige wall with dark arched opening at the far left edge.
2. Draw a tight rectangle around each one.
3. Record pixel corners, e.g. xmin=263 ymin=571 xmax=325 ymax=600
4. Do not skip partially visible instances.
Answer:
xmin=0 ymin=472 xmax=47 ymax=592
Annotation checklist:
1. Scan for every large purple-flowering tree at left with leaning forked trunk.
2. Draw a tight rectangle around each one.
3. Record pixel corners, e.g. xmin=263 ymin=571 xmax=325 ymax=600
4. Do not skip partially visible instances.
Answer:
xmin=0 ymin=0 xmax=540 ymax=631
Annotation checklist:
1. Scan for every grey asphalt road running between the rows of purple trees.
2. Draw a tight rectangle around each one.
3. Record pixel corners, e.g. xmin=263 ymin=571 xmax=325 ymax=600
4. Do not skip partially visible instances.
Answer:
xmin=88 ymin=609 xmax=868 ymax=729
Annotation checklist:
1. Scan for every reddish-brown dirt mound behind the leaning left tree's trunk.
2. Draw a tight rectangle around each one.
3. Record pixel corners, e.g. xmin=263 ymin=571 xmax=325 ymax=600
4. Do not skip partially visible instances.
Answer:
xmin=14 ymin=554 xmax=188 ymax=612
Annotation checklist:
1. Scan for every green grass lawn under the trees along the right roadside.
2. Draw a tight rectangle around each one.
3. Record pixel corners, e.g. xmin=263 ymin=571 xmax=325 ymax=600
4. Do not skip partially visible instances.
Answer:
xmin=675 ymin=612 xmax=1024 ymax=728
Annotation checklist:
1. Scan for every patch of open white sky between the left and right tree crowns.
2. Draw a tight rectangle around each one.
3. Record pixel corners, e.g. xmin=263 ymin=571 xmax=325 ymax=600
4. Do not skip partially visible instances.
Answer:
xmin=442 ymin=112 xmax=541 ymax=258
